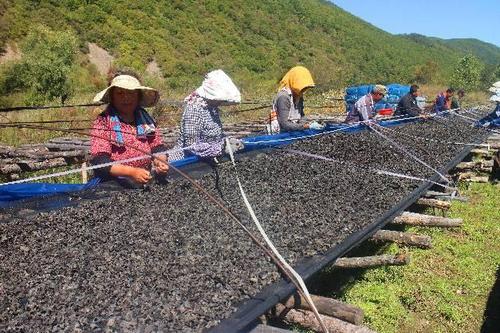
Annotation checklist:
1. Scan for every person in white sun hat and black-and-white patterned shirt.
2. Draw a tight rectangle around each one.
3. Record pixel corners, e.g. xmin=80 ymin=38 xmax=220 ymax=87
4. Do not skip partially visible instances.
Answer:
xmin=169 ymin=69 xmax=243 ymax=161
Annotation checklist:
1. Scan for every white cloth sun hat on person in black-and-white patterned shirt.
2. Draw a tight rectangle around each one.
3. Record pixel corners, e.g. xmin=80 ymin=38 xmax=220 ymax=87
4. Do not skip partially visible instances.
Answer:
xmin=196 ymin=69 xmax=241 ymax=104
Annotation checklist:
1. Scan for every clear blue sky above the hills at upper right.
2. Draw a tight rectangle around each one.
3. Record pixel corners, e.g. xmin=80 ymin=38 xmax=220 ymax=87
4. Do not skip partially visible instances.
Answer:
xmin=330 ymin=0 xmax=500 ymax=47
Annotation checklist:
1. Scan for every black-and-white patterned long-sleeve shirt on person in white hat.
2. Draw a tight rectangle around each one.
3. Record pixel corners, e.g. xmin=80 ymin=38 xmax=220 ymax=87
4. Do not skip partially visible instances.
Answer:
xmin=169 ymin=93 xmax=224 ymax=161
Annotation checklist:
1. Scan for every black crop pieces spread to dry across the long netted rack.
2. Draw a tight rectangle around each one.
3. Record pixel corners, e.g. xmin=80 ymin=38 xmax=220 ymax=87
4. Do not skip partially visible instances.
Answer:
xmin=0 ymin=113 xmax=492 ymax=332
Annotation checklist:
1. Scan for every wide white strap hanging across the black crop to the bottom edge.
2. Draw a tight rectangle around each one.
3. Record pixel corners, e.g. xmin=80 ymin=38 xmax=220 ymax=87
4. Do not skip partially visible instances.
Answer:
xmin=226 ymin=138 xmax=328 ymax=332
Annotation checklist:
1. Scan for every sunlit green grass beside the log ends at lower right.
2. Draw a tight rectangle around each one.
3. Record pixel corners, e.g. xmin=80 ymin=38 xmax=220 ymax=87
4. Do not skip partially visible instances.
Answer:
xmin=310 ymin=184 xmax=500 ymax=333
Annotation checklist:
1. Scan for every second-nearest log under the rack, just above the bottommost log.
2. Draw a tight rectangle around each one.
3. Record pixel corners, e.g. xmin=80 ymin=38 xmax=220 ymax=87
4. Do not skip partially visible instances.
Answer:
xmin=283 ymin=294 xmax=364 ymax=325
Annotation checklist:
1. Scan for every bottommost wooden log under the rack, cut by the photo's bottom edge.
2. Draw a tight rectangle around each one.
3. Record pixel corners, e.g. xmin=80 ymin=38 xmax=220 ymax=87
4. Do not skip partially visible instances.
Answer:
xmin=276 ymin=304 xmax=374 ymax=333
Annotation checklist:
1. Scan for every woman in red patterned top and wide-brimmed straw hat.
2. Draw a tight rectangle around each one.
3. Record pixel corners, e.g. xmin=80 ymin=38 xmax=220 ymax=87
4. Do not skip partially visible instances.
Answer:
xmin=90 ymin=69 xmax=168 ymax=186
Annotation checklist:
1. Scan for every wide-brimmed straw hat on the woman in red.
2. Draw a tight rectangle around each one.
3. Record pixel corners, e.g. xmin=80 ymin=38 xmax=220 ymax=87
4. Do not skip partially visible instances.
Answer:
xmin=94 ymin=75 xmax=160 ymax=107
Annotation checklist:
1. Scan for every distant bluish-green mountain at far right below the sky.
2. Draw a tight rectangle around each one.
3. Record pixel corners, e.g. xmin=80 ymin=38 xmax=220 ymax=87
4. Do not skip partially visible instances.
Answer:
xmin=401 ymin=34 xmax=500 ymax=65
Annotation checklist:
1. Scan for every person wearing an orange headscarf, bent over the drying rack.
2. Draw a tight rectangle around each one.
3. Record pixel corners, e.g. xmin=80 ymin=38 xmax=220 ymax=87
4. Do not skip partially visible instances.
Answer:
xmin=269 ymin=66 xmax=322 ymax=134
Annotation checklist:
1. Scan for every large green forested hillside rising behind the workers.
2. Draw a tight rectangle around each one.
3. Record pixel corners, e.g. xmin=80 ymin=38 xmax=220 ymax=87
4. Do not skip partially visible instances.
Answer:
xmin=0 ymin=0 xmax=500 ymax=101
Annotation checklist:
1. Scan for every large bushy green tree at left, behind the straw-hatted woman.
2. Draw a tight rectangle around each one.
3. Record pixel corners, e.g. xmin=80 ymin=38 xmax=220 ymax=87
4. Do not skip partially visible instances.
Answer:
xmin=3 ymin=26 xmax=78 ymax=105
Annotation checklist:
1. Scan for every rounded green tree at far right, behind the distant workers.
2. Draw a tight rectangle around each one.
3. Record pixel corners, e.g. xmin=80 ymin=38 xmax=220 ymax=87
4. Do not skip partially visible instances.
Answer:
xmin=450 ymin=55 xmax=484 ymax=90
